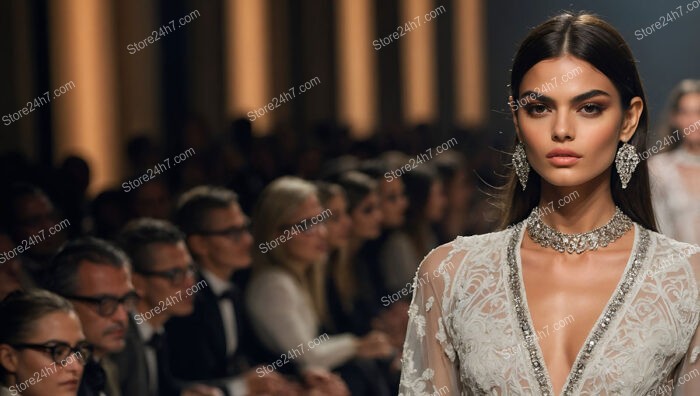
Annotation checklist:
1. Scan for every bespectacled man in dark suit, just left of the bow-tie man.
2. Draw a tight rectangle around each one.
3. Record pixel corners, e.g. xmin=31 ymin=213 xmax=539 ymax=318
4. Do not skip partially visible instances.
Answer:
xmin=112 ymin=219 xmax=222 ymax=396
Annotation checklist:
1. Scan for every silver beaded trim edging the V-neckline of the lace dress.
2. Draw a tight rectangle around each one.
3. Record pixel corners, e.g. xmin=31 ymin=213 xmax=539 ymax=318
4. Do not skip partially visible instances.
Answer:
xmin=507 ymin=222 xmax=650 ymax=396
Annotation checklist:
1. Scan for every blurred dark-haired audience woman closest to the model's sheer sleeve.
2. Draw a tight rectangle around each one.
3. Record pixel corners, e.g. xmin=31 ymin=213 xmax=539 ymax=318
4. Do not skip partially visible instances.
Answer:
xmin=379 ymin=163 xmax=446 ymax=293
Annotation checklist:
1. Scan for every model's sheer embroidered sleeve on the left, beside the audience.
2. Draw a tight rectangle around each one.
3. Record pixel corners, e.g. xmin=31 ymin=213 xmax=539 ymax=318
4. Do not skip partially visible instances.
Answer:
xmin=399 ymin=242 xmax=461 ymax=396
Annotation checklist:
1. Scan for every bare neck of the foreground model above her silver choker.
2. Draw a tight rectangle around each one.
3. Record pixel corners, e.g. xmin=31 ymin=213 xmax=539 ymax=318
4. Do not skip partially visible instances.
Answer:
xmin=538 ymin=170 xmax=615 ymax=234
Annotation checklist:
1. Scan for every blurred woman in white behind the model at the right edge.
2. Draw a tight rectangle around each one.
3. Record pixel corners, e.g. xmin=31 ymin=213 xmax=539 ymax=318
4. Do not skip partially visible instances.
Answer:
xmin=646 ymin=80 xmax=700 ymax=244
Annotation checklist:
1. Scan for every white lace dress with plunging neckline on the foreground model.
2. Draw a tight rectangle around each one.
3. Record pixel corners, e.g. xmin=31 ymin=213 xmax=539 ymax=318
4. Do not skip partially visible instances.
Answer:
xmin=399 ymin=221 xmax=700 ymax=396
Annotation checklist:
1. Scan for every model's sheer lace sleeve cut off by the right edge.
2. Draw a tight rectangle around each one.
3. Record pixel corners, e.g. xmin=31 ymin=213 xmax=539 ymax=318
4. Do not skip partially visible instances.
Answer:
xmin=673 ymin=245 xmax=700 ymax=396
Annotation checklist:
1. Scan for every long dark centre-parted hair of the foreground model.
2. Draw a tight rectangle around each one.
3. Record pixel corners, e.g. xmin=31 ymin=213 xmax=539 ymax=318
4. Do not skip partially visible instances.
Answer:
xmin=501 ymin=13 xmax=657 ymax=231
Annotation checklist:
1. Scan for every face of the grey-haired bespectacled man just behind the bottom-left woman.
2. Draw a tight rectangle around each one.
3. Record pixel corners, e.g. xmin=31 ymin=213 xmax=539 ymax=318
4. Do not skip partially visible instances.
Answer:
xmin=71 ymin=261 xmax=134 ymax=357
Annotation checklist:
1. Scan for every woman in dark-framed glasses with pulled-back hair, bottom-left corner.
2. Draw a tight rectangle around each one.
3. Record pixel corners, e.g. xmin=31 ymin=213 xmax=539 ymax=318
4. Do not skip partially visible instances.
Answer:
xmin=0 ymin=290 xmax=90 ymax=396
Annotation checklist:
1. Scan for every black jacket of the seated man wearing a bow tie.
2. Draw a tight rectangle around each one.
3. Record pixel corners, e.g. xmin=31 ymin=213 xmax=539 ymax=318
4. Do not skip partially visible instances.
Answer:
xmin=165 ymin=274 xmax=289 ymax=392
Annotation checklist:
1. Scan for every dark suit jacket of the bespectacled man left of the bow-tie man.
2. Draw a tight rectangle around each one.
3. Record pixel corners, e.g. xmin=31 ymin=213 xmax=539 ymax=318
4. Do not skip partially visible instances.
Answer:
xmin=112 ymin=317 xmax=183 ymax=396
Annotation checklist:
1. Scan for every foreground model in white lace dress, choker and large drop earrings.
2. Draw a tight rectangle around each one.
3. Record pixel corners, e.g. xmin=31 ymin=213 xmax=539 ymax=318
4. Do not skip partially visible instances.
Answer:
xmin=401 ymin=13 xmax=700 ymax=395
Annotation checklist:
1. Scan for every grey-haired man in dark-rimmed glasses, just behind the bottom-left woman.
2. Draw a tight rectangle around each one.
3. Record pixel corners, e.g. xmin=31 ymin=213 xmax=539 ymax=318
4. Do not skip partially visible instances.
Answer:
xmin=44 ymin=237 xmax=139 ymax=396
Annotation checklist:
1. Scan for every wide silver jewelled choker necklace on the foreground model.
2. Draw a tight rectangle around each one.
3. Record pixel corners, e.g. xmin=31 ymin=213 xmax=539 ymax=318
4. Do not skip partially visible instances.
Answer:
xmin=527 ymin=206 xmax=633 ymax=254
